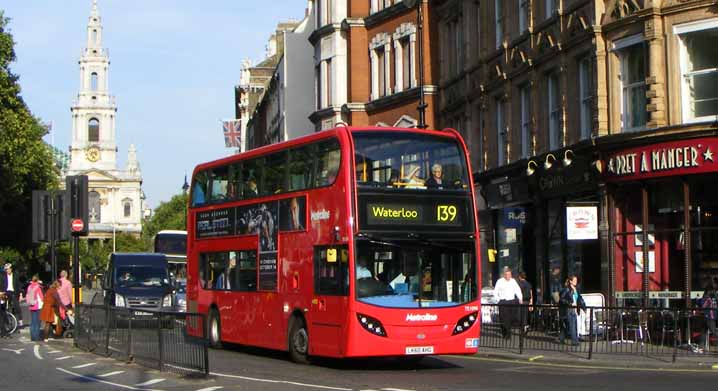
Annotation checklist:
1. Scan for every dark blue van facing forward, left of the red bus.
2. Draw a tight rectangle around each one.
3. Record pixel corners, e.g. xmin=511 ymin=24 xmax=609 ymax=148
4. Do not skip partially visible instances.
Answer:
xmin=102 ymin=253 xmax=175 ymax=311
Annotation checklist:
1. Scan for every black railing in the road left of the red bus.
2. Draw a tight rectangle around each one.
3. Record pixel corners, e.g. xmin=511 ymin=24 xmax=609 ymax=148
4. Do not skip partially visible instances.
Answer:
xmin=74 ymin=304 xmax=209 ymax=376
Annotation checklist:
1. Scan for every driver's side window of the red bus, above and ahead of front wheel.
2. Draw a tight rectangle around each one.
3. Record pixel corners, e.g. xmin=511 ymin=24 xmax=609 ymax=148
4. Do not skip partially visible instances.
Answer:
xmin=314 ymin=246 xmax=349 ymax=296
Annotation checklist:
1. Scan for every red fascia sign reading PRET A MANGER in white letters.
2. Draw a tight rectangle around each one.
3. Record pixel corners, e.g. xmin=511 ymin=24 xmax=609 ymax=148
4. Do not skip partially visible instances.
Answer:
xmin=606 ymin=138 xmax=718 ymax=179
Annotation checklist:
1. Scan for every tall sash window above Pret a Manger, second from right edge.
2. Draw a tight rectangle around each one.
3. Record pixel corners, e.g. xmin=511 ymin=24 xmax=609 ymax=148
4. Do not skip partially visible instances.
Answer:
xmin=614 ymin=35 xmax=648 ymax=131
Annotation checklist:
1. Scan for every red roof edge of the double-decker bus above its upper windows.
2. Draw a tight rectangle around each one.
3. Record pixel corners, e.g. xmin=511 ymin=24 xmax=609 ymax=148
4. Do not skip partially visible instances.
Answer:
xmin=193 ymin=125 xmax=459 ymax=176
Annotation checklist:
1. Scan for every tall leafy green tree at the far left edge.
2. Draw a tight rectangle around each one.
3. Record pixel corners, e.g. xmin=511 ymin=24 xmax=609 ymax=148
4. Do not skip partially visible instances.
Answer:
xmin=0 ymin=10 xmax=58 ymax=254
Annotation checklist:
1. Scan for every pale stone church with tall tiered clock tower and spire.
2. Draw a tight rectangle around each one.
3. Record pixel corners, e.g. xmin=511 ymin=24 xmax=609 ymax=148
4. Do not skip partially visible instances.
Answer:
xmin=63 ymin=0 xmax=144 ymax=239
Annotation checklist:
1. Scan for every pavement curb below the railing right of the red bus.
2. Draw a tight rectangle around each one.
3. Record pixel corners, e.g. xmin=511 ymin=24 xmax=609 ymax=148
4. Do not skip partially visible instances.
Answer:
xmin=469 ymin=352 xmax=718 ymax=373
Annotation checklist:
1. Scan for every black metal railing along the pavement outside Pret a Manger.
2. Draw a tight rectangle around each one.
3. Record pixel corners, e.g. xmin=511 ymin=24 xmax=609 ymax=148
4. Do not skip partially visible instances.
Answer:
xmin=480 ymin=304 xmax=718 ymax=362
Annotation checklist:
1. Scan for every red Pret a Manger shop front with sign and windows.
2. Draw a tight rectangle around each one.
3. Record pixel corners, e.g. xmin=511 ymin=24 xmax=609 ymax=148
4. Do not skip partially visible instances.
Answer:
xmin=604 ymin=137 xmax=718 ymax=306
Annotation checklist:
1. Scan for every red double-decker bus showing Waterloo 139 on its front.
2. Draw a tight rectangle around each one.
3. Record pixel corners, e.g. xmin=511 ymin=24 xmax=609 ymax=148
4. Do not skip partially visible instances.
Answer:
xmin=187 ymin=127 xmax=481 ymax=362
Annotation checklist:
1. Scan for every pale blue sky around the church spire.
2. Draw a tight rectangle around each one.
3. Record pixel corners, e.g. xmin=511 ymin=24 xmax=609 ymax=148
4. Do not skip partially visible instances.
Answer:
xmin=0 ymin=0 xmax=307 ymax=208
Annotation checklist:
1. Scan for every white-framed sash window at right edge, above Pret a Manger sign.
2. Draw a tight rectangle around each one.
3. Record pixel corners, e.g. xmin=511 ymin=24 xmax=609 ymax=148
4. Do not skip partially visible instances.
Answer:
xmin=675 ymin=19 xmax=718 ymax=122
